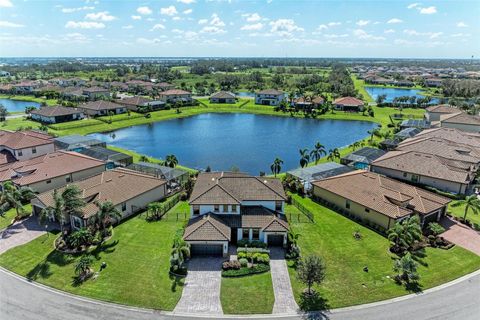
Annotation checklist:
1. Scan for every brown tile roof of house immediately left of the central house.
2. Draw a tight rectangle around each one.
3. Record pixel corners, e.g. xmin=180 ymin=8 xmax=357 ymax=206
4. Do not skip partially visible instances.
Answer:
xmin=37 ymin=168 xmax=166 ymax=218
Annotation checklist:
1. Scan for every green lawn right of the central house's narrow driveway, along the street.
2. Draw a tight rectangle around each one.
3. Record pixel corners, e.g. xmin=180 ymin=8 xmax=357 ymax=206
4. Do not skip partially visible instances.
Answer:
xmin=289 ymin=195 xmax=480 ymax=309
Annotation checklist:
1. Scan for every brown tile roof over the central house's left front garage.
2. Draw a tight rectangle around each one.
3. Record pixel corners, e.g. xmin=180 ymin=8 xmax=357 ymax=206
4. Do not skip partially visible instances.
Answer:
xmin=183 ymin=214 xmax=231 ymax=241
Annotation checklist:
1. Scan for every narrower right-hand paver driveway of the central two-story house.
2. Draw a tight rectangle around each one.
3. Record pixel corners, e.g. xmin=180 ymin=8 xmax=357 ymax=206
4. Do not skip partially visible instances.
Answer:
xmin=270 ymin=248 xmax=299 ymax=314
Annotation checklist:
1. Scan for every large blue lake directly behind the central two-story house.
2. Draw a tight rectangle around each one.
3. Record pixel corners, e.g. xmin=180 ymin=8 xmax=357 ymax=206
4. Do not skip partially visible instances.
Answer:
xmin=90 ymin=113 xmax=377 ymax=175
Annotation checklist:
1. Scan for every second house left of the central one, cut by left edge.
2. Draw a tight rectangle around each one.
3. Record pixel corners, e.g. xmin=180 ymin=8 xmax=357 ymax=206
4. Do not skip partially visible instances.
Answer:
xmin=0 ymin=151 xmax=105 ymax=192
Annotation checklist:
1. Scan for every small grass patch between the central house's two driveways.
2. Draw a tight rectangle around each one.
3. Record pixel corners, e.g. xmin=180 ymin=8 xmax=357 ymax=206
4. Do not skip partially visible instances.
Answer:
xmin=220 ymin=272 xmax=275 ymax=314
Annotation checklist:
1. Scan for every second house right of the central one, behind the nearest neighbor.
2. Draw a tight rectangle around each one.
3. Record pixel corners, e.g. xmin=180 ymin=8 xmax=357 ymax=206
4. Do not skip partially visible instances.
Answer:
xmin=370 ymin=151 xmax=475 ymax=194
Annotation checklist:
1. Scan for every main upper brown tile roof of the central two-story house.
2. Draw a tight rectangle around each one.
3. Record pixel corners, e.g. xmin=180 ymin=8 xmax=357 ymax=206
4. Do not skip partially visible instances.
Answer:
xmin=190 ymin=172 xmax=286 ymax=204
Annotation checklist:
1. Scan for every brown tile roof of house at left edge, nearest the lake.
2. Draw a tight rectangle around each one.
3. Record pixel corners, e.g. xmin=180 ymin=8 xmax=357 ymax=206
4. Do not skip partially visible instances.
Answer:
xmin=0 ymin=130 xmax=53 ymax=150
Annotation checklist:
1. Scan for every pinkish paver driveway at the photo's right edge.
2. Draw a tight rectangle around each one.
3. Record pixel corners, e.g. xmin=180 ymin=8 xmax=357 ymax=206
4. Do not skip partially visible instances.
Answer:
xmin=440 ymin=217 xmax=480 ymax=255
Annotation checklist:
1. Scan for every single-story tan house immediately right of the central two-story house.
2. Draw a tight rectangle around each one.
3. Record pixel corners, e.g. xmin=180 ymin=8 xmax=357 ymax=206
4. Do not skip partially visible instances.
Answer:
xmin=313 ymin=170 xmax=450 ymax=231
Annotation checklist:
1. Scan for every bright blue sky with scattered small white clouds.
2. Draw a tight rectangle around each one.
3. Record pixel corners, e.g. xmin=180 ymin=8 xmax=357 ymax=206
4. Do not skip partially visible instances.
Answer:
xmin=0 ymin=0 xmax=480 ymax=59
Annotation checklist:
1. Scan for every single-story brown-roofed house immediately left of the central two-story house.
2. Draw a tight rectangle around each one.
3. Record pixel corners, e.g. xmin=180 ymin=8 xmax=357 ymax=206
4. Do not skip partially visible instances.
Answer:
xmin=32 ymin=168 xmax=166 ymax=229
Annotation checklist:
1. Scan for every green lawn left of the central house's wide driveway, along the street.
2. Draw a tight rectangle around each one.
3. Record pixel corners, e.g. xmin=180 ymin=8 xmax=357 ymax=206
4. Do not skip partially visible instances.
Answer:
xmin=0 ymin=214 xmax=187 ymax=310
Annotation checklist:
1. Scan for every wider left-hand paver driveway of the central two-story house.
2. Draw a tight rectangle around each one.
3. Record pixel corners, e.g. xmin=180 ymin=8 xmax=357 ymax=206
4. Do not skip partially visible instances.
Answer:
xmin=173 ymin=257 xmax=224 ymax=315
